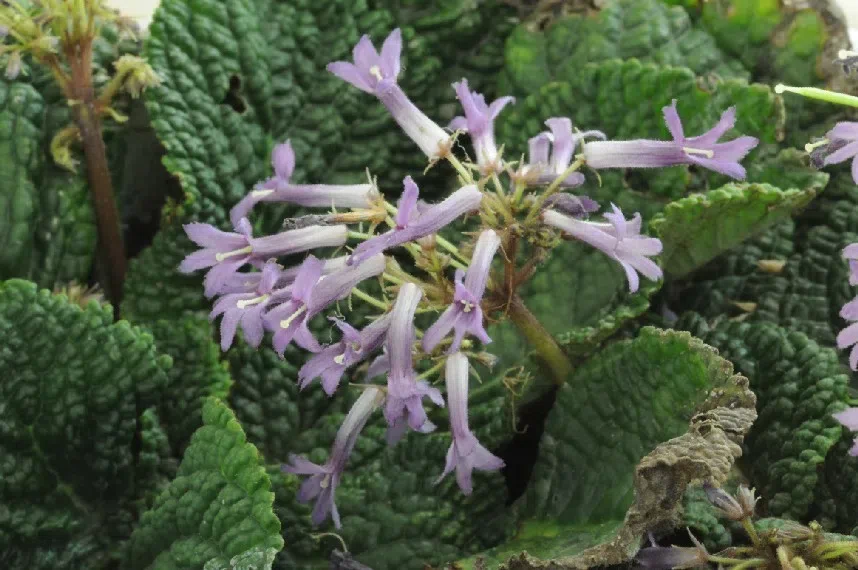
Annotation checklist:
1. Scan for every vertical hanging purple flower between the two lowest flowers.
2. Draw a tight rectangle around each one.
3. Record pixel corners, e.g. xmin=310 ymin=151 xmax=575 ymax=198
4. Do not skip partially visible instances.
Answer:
xmin=384 ymin=283 xmax=444 ymax=444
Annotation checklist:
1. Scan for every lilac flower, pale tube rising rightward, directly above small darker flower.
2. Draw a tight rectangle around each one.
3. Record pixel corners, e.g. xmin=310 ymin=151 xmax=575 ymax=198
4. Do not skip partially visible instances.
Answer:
xmin=264 ymin=254 xmax=386 ymax=355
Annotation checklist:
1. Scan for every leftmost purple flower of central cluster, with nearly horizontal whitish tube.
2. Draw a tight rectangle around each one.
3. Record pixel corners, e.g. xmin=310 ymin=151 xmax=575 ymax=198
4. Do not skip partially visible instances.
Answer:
xmin=179 ymin=218 xmax=348 ymax=297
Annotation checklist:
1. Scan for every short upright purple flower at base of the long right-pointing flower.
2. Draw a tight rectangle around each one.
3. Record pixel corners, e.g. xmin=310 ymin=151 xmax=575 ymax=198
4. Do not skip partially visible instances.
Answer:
xmin=526 ymin=117 xmax=605 ymax=188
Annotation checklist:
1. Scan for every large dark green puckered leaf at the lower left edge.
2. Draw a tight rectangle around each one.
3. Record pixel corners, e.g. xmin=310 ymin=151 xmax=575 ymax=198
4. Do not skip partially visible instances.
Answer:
xmin=0 ymin=280 xmax=170 ymax=569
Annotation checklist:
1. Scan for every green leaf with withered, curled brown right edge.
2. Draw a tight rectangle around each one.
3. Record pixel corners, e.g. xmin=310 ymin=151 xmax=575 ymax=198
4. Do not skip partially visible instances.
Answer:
xmin=466 ymin=327 xmax=756 ymax=568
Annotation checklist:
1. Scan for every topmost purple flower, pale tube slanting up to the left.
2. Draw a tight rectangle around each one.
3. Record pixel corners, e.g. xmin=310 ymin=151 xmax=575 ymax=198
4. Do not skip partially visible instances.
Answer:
xmin=327 ymin=28 xmax=451 ymax=159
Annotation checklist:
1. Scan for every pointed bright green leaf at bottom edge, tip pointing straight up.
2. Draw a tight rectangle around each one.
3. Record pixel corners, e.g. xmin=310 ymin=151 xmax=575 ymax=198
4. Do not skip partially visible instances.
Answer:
xmin=125 ymin=398 xmax=283 ymax=570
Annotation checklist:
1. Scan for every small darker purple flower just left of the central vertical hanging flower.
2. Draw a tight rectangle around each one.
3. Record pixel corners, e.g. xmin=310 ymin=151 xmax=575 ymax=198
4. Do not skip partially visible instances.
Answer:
xmin=298 ymin=314 xmax=390 ymax=396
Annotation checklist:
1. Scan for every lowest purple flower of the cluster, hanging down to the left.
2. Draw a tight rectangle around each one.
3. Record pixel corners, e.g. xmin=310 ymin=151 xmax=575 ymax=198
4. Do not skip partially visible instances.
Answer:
xmin=282 ymin=387 xmax=384 ymax=528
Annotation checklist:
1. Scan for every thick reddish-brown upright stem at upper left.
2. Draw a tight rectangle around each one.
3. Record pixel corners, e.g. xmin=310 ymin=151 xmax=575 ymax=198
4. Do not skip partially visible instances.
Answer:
xmin=66 ymin=41 xmax=126 ymax=317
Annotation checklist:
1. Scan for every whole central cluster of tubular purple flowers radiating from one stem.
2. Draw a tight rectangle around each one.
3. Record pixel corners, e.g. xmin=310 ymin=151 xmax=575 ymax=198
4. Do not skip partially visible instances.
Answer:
xmin=181 ymin=30 xmax=756 ymax=526
